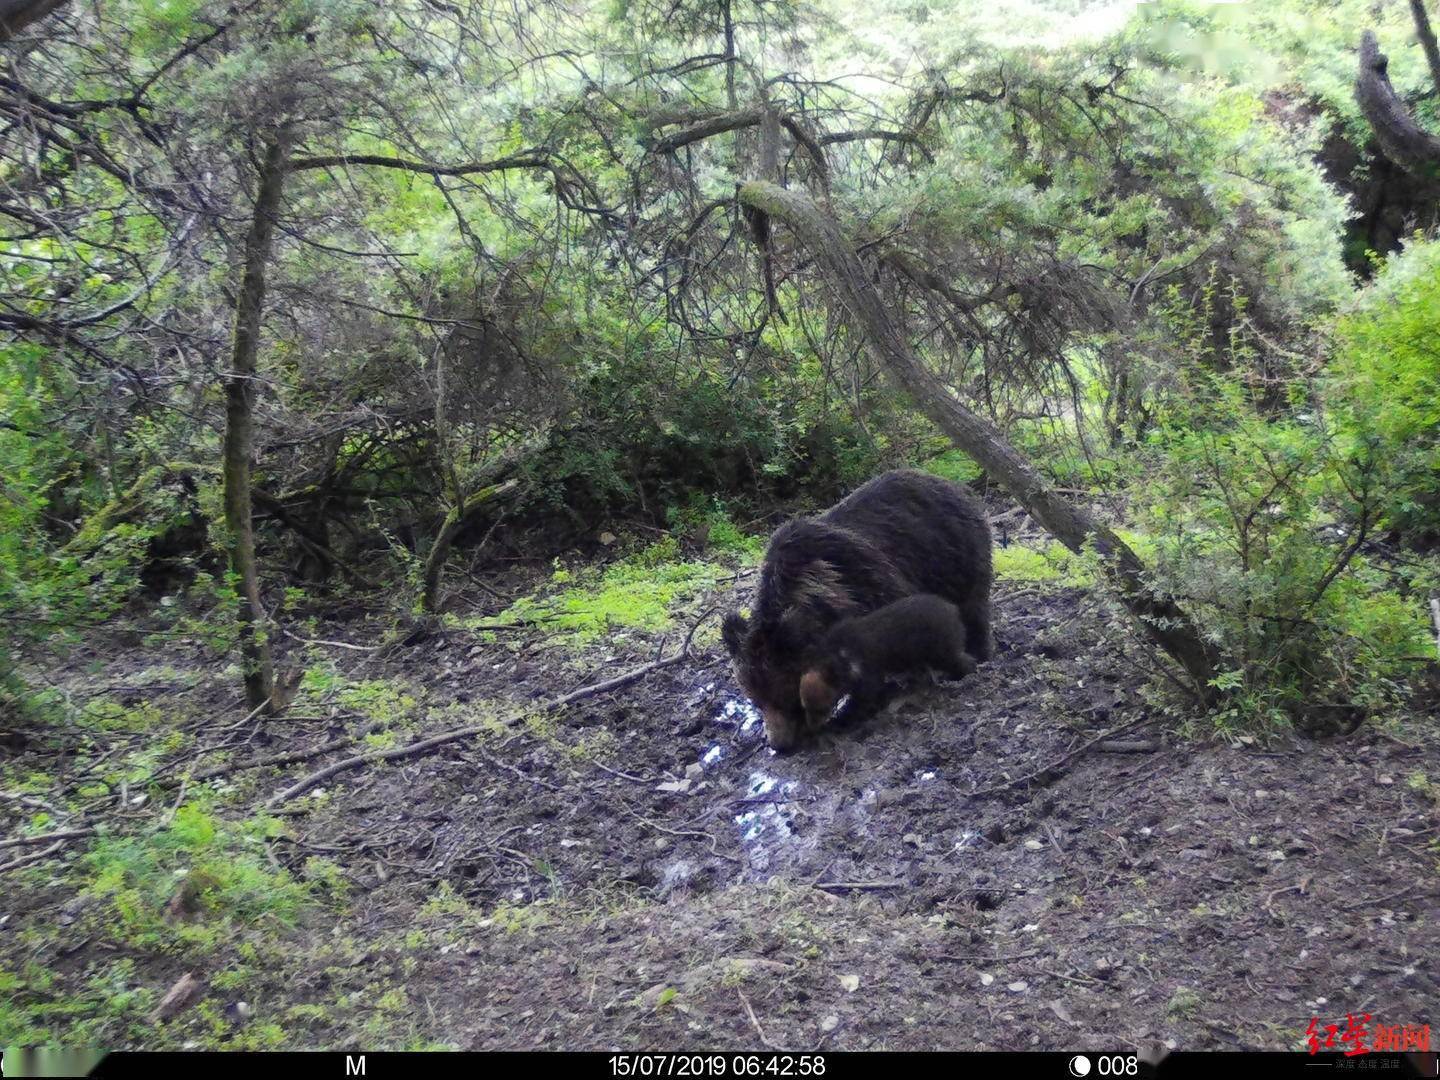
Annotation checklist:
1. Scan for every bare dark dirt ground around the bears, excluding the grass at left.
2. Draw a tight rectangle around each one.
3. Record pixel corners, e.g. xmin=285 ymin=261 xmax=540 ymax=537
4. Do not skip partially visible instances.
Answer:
xmin=0 ymin=544 xmax=1440 ymax=1050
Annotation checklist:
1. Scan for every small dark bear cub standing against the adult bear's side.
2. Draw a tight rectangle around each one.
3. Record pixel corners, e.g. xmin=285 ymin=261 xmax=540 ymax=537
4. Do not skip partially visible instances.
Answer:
xmin=801 ymin=592 xmax=975 ymax=732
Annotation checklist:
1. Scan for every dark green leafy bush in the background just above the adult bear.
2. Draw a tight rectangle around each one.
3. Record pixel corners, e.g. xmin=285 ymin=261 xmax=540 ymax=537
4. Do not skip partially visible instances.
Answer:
xmin=512 ymin=346 xmax=904 ymax=531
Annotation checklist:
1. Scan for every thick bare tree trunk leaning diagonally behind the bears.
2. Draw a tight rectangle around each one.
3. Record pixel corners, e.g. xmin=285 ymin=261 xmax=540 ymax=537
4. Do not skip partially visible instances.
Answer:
xmin=739 ymin=181 xmax=1217 ymax=701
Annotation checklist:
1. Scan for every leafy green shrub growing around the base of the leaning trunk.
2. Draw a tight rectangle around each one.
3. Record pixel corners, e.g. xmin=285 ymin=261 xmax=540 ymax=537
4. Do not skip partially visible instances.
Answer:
xmin=1139 ymin=377 xmax=1427 ymax=730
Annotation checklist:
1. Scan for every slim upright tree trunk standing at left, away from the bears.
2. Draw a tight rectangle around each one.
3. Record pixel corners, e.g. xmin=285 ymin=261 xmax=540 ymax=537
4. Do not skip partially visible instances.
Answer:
xmin=223 ymin=125 xmax=294 ymax=713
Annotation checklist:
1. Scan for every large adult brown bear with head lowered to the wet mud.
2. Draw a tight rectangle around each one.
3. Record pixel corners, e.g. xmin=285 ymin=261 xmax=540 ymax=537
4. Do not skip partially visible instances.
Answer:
xmin=723 ymin=469 xmax=992 ymax=750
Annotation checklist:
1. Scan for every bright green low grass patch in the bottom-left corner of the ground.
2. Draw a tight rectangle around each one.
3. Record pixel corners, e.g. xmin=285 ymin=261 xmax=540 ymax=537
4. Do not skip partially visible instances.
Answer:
xmin=0 ymin=802 xmax=338 ymax=1050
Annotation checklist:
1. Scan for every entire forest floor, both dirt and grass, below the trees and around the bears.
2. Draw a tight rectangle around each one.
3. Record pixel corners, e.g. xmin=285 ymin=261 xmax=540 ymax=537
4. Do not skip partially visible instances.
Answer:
xmin=0 ymin=529 xmax=1440 ymax=1050
